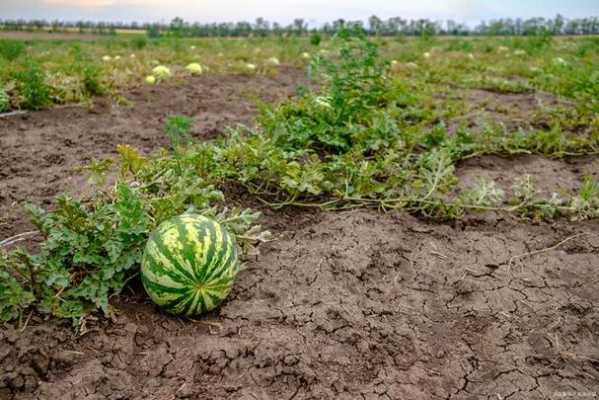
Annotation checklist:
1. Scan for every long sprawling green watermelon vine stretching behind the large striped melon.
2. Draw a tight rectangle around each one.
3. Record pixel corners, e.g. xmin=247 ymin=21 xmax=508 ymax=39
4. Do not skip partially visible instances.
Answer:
xmin=0 ymin=31 xmax=599 ymax=326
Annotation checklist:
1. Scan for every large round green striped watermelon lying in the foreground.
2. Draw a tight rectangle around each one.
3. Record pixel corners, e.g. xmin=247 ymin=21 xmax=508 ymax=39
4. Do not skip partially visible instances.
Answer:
xmin=141 ymin=214 xmax=239 ymax=316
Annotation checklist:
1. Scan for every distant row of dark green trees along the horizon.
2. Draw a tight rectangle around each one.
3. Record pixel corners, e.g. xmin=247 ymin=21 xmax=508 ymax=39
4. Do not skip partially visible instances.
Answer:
xmin=0 ymin=14 xmax=599 ymax=37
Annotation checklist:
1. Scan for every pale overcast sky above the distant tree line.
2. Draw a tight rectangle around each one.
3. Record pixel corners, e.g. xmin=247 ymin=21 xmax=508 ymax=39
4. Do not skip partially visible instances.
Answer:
xmin=0 ymin=0 xmax=599 ymax=25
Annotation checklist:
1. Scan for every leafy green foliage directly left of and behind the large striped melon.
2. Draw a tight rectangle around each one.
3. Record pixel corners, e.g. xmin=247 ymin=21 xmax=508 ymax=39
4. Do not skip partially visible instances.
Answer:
xmin=0 ymin=145 xmax=265 ymax=325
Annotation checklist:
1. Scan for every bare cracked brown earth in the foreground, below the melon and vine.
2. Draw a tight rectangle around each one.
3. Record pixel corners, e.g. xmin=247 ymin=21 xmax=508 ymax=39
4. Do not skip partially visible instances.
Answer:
xmin=0 ymin=211 xmax=599 ymax=399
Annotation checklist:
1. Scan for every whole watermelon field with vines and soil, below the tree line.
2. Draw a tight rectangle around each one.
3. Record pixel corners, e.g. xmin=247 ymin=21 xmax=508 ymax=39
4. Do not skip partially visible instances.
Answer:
xmin=0 ymin=29 xmax=599 ymax=400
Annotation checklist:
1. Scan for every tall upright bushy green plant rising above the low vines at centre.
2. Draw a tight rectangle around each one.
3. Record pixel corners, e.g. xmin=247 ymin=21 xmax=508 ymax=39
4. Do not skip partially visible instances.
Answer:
xmin=260 ymin=31 xmax=399 ymax=154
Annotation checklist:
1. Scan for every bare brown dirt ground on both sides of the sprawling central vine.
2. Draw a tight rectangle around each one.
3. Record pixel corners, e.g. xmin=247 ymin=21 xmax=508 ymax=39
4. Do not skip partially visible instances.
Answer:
xmin=0 ymin=69 xmax=599 ymax=400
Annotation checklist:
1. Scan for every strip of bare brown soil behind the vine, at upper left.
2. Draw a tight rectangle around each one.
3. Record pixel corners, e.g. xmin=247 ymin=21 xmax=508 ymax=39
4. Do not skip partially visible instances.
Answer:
xmin=0 ymin=67 xmax=307 ymax=238
